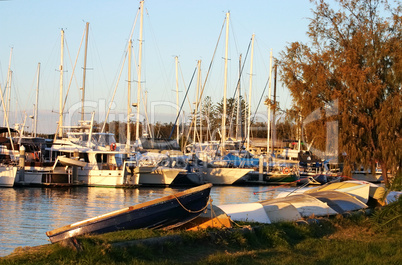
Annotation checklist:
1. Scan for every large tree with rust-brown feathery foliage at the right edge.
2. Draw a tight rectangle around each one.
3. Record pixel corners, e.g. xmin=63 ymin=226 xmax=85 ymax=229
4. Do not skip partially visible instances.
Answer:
xmin=279 ymin=0 xmax=402 ymax=184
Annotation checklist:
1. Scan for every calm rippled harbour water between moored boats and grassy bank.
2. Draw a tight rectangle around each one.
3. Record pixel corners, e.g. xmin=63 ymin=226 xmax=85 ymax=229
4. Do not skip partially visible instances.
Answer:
xmin=0 ymin=186 xmax=284 ymax=256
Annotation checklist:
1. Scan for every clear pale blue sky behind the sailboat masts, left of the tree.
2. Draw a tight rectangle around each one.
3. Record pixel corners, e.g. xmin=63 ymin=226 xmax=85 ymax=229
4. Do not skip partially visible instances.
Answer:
xmin=0 ymin=0 xmax=320 ymax=133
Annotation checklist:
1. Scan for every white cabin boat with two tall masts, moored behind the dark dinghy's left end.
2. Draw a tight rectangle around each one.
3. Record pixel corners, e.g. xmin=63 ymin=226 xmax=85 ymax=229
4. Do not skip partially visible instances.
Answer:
xmin=38 ymin=23 xmax=138 ymax=187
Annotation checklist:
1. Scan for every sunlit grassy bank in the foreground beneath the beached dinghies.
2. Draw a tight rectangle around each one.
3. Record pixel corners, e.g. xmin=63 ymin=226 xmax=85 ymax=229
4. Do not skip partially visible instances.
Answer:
xmin=0 ymin=198 xmax=402 ymax=265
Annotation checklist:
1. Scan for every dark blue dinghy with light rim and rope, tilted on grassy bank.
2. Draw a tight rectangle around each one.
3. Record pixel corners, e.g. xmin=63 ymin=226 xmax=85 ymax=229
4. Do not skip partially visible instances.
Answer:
xmin=46 ymin=184 xmax=212 ymax=243
